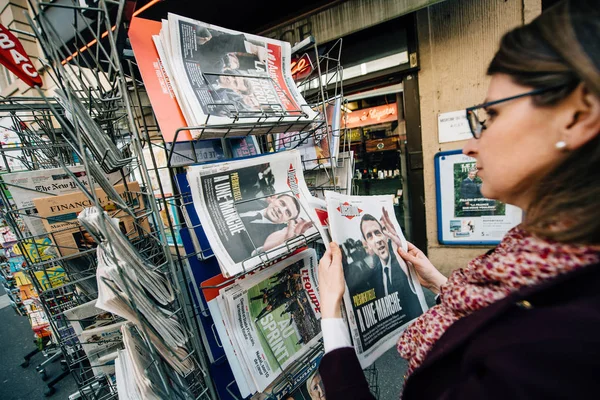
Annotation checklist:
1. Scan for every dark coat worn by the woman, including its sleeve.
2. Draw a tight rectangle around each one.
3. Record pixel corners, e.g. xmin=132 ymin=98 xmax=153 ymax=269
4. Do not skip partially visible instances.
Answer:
xmin=319 ymin=264 xmax=600 ymax=400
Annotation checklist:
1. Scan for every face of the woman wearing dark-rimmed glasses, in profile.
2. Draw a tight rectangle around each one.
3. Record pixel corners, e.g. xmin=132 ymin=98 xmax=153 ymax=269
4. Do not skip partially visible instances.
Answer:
xmin=463 ymin=74 xmax=566 ymax=209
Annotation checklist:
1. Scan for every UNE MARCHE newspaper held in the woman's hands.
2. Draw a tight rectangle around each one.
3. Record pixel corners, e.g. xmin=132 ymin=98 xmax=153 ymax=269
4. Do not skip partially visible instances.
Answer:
xmin=326 ymin=192 xmax=427 ymax=368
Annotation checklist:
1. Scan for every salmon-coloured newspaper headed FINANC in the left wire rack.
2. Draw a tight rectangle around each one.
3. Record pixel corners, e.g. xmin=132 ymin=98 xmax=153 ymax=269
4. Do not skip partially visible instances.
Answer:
xmin=33 ymin=182 xmax=150 ymax=256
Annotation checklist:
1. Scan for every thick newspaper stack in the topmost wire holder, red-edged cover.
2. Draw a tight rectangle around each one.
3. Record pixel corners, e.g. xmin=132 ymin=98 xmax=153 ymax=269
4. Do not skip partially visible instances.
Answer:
xmin=129 ymin=14 xmax=317 ymax=141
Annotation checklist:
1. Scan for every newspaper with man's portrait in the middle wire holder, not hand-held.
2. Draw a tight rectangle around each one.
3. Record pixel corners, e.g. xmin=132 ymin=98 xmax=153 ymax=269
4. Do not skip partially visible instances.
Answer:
xmin=188 ymin=151 xmax=319 ymax=276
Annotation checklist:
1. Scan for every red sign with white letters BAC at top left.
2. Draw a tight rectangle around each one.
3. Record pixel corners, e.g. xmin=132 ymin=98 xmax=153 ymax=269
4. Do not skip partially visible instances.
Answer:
xmin=0 ymin=25 xmax=42 ymax=87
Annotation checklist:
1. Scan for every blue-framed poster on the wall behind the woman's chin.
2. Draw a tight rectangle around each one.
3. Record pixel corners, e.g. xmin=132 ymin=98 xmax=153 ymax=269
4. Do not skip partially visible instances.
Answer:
xmin=434 ymin=150 xmax=523 ymax=245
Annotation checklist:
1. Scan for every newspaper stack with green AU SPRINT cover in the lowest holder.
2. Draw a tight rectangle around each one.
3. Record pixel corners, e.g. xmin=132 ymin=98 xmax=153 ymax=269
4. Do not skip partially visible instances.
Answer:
xmin=223 ymin=249 xmax=321 ymax=392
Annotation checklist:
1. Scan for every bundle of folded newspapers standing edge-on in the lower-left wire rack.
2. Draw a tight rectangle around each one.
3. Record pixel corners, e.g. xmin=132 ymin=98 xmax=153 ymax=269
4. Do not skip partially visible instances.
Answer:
xmin=78 ymin=208 xmax=195 ymax=398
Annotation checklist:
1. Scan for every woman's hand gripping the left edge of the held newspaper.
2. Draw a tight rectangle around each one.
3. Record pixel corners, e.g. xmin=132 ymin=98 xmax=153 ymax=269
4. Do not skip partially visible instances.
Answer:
xmin=319 ymin=242 xmax=346 ymax=318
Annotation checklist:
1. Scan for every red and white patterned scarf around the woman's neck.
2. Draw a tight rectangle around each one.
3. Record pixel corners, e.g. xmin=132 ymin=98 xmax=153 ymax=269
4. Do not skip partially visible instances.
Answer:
xmin=397 ymin=226 xmax=600 ymax=377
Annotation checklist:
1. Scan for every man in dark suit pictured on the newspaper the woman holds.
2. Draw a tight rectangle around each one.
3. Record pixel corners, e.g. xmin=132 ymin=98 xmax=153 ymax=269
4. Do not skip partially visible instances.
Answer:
xmin=360 ymin=209 xmax=423 ymax=320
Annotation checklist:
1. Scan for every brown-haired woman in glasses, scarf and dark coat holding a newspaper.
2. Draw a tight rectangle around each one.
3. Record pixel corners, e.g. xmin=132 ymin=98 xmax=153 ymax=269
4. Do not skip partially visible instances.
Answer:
xmin=319 ymin=1 xmax=600 ymax=400
